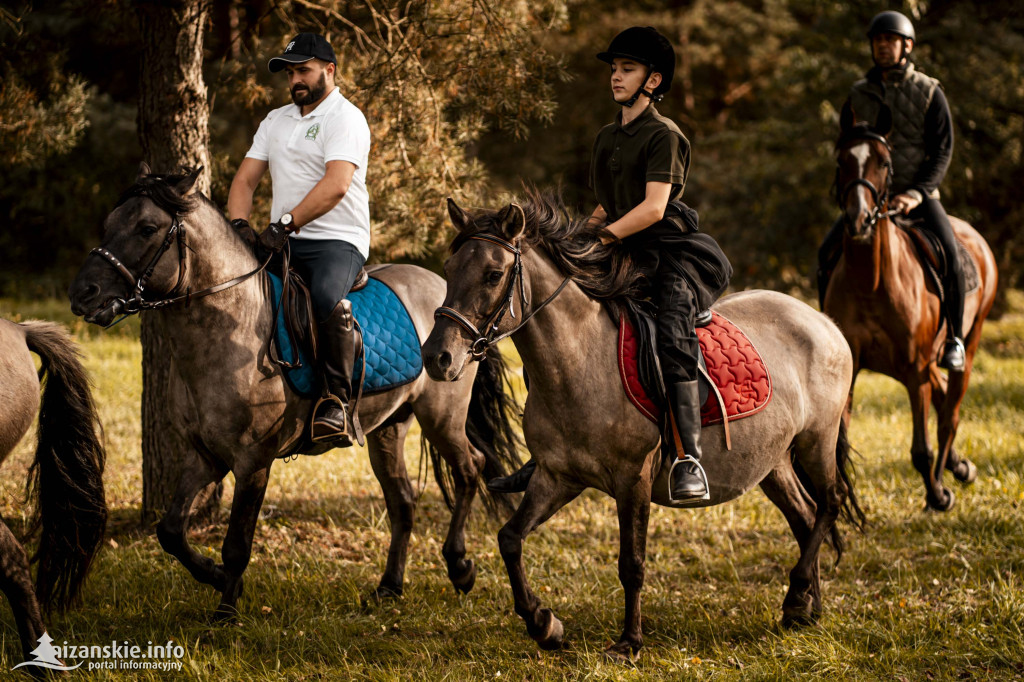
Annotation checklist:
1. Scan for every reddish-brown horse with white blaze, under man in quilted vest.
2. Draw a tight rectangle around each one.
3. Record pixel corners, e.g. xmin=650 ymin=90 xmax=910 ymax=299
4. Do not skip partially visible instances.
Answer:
xmin=823 ymin=116 xmax=998 ymax=511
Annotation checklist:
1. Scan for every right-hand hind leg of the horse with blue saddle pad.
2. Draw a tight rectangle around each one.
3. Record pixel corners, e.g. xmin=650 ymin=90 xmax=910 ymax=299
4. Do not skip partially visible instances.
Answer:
xmin=417 ymin=395 xmax=484 ymax=594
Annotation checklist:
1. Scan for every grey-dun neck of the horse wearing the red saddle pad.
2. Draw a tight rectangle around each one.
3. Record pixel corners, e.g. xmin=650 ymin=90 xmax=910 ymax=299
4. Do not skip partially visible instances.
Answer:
xmin=512 ymin=248 xmax=617 ymax=397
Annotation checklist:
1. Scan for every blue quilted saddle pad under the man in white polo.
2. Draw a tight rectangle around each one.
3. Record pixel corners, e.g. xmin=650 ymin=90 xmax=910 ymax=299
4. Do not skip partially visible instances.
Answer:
xmin=267 ymin=272 xmax=423 ymax=397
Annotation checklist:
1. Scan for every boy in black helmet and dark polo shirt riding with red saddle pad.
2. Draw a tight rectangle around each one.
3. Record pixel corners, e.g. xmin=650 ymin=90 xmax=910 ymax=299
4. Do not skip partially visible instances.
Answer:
xmin=488 ymin=27 xmax=732 ymax=502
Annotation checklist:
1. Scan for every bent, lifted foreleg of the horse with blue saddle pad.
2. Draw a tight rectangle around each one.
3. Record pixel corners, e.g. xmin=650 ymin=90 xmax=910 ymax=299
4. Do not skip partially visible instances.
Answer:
xmin=157 ymin=452 xmax=227 ymax=591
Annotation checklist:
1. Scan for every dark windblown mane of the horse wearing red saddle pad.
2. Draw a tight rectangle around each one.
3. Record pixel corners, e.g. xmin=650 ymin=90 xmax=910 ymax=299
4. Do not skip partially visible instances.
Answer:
xmin=451 ymin=185 xmax=644 ymax=300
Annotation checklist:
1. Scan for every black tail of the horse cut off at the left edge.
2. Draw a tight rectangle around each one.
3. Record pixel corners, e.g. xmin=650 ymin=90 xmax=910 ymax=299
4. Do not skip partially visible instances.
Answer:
xmin=22 ymin=322 xmax=106 ymax=610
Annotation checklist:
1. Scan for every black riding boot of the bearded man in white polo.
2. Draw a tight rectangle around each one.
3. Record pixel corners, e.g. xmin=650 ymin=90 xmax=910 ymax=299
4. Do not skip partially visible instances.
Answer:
xmin=311 ymin=300 xmax=356 ymax=447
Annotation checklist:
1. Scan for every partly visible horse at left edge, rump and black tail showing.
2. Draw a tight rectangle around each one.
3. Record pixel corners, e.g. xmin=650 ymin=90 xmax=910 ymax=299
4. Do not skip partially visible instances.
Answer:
xmin=0 ymin=319 xmax=106 ymax=660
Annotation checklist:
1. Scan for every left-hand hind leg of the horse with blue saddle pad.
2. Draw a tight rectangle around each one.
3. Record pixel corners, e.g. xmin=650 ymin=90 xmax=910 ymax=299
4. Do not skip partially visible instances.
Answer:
xmin=367 ymin=415 xmax=416 ymax=601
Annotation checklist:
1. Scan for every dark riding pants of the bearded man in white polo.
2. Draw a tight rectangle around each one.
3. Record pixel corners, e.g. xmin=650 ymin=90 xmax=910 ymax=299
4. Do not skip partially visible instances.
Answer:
xmin=269 ymin=239 xmax=366 ymax=323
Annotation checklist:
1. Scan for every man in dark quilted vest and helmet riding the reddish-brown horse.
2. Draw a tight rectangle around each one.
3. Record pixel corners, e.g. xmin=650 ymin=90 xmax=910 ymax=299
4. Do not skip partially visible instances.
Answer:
xmin=818 ymin=11 xmax=965 ymax=372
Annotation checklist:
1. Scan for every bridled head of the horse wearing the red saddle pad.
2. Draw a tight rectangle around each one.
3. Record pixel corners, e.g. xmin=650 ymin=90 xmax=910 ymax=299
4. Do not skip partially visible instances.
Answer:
xmin=422 ymin=199 xmax=528 ymax=381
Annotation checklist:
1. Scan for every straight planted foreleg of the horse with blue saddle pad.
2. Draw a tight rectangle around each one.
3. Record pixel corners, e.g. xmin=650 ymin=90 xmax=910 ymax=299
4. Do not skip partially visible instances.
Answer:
xmin=216 ymin=461 xmax=272 ymax=617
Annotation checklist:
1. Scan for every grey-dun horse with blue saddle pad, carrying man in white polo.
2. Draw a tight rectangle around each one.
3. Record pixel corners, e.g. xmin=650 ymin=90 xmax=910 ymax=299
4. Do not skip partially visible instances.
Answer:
xmin=70 ymin=164 xmax=518 ymax=617
